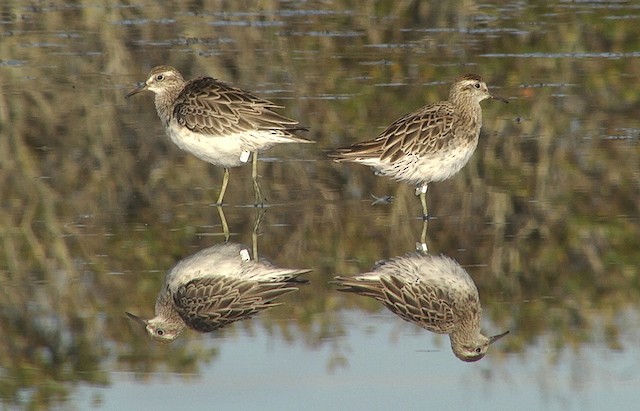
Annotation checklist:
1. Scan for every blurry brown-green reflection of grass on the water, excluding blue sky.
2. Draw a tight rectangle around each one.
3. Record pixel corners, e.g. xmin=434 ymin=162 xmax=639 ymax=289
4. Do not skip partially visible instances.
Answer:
xmin=0 ymin=1 xmax=640 ymax=406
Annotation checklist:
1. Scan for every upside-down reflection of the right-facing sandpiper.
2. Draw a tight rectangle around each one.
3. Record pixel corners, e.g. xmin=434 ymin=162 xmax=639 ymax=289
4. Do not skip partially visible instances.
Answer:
xmin=335 ymin=252 xmax=509 ymax=362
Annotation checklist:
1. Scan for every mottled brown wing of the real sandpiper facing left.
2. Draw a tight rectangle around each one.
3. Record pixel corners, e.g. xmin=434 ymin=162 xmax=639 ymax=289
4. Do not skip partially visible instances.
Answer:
xmin=173 ymin=77 xmax=301 ymax=136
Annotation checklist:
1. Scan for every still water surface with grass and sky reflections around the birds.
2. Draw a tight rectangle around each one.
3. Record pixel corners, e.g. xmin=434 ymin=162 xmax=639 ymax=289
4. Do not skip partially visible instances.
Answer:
xmin=0 ymin=0 xmax=640 ymax=410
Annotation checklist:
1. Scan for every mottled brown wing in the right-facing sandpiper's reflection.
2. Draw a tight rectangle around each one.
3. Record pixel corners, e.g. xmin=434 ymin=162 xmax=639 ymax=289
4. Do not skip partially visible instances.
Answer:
xmin=380 ymin=276 xmax=456 ymax=334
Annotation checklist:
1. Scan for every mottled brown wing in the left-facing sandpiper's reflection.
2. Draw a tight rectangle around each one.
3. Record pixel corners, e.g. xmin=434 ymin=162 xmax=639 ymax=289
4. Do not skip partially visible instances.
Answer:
xmin=173 ymin=276 xmax=297 ymax=332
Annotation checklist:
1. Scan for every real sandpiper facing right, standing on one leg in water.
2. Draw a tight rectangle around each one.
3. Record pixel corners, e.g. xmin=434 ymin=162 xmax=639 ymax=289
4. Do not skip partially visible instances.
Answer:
xmin=329 ymin=74 xmax=508 ymax=218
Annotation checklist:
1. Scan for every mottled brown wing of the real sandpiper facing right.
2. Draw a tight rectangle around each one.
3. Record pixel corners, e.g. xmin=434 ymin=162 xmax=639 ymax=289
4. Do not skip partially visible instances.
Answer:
xmin=330 ymin=101 xmax=455 ymax=163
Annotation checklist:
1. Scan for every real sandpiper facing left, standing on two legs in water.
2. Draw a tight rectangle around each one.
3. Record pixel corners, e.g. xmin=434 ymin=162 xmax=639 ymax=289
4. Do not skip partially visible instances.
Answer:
xmin=126 ymin=66 xmax=311 ymax=204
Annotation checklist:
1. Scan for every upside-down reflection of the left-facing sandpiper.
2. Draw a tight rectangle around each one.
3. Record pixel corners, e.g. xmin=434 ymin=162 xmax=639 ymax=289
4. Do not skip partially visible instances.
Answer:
xmin=126 ymin=243 xmax=311 ymax=342
